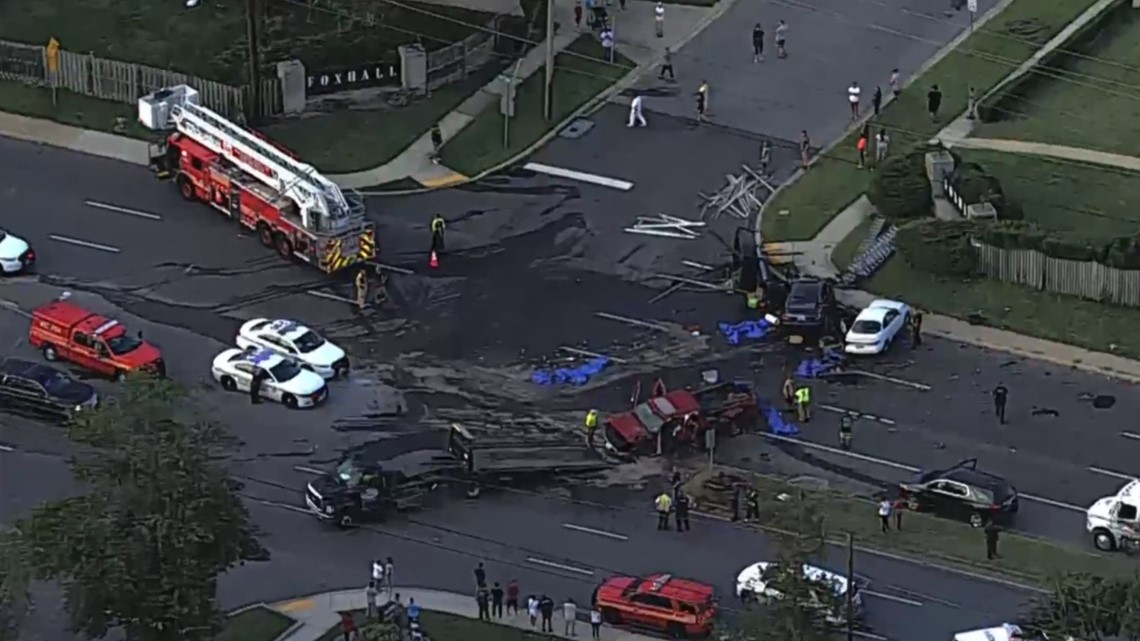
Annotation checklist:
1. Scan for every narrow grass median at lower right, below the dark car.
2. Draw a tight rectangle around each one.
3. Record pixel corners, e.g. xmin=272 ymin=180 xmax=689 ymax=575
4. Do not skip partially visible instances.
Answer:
xmin=686 ymin=463 xmax=1135 ymax=585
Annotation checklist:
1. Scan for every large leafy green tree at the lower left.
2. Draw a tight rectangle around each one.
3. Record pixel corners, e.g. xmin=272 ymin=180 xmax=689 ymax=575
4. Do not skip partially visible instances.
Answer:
xmin=18 ymin=376 xmax=264 ymax=641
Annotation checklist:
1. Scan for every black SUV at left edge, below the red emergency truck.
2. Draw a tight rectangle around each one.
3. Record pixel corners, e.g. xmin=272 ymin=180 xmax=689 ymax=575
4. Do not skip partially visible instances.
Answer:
xmin=0 ymin=358 xmax=99 ymax=420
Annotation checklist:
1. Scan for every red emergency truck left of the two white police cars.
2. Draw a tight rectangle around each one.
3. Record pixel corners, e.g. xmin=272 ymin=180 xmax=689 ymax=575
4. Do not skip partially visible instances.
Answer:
xmin=27 ymin=300 xmax=166 ymax=379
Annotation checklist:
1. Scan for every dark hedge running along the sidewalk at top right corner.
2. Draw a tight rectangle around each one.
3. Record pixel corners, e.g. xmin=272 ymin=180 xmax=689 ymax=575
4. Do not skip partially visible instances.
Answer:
xmin=976 ymin=0 xmax=1135 ymax=122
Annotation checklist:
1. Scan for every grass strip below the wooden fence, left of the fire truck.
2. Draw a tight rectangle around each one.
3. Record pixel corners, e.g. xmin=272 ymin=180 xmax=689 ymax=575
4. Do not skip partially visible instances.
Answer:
xmin=0 ymin=80 xmax=149 ymax=139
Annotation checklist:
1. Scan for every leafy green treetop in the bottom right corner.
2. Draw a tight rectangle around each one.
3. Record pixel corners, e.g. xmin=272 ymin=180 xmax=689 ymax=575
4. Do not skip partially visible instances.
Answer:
xmin=1024 ymin=573 xmax=1140 ymax=641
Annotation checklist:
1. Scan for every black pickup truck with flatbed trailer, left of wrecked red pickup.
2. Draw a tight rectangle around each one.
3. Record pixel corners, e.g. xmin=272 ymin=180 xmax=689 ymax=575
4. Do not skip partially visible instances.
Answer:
xmin=304 ymin=424 xmax=613 ymax=527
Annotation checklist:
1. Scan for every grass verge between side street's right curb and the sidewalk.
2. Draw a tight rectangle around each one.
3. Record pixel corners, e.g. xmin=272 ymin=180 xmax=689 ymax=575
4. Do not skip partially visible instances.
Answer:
xmin=762 ymin=0 xmax=1096 ymax=241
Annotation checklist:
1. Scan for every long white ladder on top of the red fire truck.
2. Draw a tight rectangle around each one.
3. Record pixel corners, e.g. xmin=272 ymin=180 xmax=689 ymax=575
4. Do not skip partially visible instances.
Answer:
xmin=170 ymin=103 xmax=364 ymax=232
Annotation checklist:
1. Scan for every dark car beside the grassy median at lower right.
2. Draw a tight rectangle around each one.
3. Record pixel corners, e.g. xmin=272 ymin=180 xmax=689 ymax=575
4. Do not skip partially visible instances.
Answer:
xmin=898 ymin=459 xmax=1018 ymax=527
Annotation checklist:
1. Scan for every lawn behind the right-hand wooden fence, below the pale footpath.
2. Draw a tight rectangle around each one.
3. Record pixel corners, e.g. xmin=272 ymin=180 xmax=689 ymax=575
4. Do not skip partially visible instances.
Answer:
xmin=961 ymin=149 xmax=1140 ymax=240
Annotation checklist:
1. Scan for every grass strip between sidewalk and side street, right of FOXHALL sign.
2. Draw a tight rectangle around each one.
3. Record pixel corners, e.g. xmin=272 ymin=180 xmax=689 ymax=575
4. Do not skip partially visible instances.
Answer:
xmin=441 ymin=34 xmax=635 ymax=176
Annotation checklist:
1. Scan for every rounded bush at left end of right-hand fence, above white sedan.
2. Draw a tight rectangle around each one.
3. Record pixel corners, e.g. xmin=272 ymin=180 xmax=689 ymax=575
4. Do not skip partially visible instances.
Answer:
xmin=895 ymin=219 xmax=979 ymax=276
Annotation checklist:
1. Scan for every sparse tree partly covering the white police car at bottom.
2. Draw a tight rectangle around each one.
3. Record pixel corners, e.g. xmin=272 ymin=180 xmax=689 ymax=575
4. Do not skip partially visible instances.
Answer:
xmin=730 ymin=485 xmax=846 ymax=641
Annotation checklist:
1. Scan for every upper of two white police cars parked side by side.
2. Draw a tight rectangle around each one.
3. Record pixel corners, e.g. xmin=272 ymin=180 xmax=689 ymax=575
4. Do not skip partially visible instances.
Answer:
xmin=236 ymin=318 xmax=349 ymax=379
